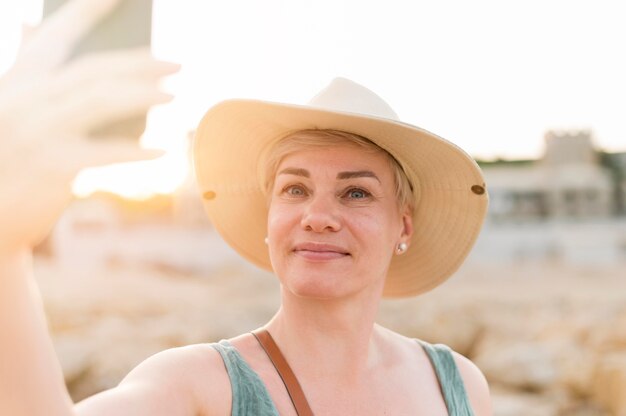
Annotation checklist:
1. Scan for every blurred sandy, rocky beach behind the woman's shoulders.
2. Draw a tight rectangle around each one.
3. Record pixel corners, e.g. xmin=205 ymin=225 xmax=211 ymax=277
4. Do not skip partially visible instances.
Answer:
xmin=36 ymin=256 xmax=626 ymax=416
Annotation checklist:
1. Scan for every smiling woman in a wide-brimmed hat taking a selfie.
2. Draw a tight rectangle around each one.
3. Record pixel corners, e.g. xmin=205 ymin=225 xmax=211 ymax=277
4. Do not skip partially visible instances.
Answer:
xmin=0 ymin=4 xmax=491 ymax=416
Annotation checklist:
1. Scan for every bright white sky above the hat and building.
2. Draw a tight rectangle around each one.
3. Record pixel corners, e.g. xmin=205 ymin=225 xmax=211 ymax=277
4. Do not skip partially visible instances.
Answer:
xmin=0 ymin=0 xmax=626 ymax=197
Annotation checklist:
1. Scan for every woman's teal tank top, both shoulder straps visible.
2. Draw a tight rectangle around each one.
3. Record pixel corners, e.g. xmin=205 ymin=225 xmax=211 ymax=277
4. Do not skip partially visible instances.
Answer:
xmin=211 ymin=340 xmax=474 ymax=416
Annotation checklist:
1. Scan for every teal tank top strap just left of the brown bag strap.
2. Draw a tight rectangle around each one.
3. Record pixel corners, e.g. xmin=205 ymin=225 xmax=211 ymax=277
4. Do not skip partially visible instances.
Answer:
xmin=211 ymin=340 xmax=278 ymax=416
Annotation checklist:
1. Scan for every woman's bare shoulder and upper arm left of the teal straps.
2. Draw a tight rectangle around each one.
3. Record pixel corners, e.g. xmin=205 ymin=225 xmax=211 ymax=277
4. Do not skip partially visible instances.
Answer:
xmin=76 ymin=344 xmax=232 ymax=415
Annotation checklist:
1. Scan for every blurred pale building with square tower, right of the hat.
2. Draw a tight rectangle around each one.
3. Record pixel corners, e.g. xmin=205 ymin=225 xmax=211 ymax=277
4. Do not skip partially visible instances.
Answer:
xmin=481 ymin=130 xmax=626 ymax=223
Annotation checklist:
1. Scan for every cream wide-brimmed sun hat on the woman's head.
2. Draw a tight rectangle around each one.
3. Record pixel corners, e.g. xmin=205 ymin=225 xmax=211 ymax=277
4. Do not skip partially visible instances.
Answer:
xmin=194 ymin=78 xmax=488 ymax=297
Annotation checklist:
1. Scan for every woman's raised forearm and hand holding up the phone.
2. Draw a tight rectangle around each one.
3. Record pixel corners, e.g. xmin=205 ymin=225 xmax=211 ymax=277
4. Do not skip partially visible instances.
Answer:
xmin=0 ymin=0 xmax=177 ymax=415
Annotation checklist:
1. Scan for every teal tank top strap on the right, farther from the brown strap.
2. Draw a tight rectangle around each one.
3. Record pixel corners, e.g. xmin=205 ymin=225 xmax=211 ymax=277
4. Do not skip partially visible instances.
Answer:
xmin=417 ymin=340 xmax=474 ymax=416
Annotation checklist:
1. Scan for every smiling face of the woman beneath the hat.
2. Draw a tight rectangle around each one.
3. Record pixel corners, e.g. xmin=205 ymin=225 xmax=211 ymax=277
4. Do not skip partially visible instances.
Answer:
xmin=268 ymin=144 xmax=412 ymax=299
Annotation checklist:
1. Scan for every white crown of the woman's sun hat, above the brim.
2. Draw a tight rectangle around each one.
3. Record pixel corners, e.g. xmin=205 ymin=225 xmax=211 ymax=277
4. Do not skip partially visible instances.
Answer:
xmin=309 ymin=78 xmax=399 ymax=120
